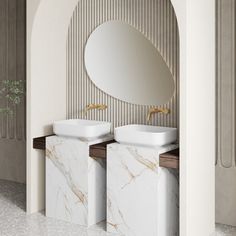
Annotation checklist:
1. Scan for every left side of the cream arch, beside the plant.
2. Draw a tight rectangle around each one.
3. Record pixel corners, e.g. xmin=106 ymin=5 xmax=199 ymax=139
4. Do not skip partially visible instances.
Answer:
xmin=27 ymin=0 xmax=77 ymax=213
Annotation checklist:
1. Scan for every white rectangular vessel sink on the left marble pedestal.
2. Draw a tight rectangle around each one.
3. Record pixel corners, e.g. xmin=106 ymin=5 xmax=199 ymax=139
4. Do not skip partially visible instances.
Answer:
xmin=53 ymin=119 xmax=111 ymax=140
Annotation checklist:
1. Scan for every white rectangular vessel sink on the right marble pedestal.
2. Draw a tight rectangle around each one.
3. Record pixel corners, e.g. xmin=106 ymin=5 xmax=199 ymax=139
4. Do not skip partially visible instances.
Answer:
xmin=114 ymin=125 xmax=177 ymax=147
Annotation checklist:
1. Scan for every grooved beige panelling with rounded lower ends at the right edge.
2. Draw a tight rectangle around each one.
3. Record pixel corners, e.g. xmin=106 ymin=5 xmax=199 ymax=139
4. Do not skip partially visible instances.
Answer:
xmin=216 ymin=0 xmax=236 ymax=168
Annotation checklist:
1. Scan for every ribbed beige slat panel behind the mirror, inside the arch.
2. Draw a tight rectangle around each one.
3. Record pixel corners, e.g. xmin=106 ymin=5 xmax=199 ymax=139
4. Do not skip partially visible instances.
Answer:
xmin=67 ymin=0 xmax=179 ymax=133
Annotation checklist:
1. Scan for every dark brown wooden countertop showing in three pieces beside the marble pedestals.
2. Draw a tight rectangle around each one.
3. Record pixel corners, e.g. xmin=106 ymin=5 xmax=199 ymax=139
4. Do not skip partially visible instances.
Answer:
xmin=33 ymin=135 xmax=179 ymax=169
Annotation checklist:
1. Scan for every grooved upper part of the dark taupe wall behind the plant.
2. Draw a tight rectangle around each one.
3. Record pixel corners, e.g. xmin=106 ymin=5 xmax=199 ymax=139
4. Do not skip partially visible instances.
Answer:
xmin=0 ymin=0 xmax=26 ymax=140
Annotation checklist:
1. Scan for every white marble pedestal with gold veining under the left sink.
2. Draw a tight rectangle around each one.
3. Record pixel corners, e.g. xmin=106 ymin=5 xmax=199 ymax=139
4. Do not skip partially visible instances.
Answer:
xmin=46 ymin=136 xmax=111 ymax=227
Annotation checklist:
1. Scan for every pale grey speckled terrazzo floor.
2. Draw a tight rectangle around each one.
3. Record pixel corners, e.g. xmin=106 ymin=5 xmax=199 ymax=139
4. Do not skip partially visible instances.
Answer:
xmin=0 ymin=180 xmax=236 ymax=236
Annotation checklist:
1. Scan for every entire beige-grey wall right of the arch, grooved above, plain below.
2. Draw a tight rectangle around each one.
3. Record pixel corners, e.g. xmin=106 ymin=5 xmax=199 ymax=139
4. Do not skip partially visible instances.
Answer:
xmin=216 ymin=0 xmax=236 ymax=226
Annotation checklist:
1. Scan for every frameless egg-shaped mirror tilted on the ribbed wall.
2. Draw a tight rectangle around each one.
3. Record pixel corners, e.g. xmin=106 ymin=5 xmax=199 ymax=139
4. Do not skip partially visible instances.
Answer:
xmin=84 ymin=21 xmax=175 ymax=105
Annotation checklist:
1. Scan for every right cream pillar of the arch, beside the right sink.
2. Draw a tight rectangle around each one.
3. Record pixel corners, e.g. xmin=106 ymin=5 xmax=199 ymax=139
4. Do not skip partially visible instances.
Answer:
xmin=172 ymin=0 xmax=215 ymax=236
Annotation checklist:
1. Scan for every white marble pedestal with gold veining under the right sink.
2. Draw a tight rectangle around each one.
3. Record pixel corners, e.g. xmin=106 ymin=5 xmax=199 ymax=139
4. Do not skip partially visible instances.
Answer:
xmin=107 ymin=143 xmax=179 ymax=236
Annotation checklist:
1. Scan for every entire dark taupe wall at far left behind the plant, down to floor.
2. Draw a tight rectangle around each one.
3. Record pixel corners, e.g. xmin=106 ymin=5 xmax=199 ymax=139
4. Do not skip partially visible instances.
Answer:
xmin=0 ymin=0 xmax=26 ymax=183
